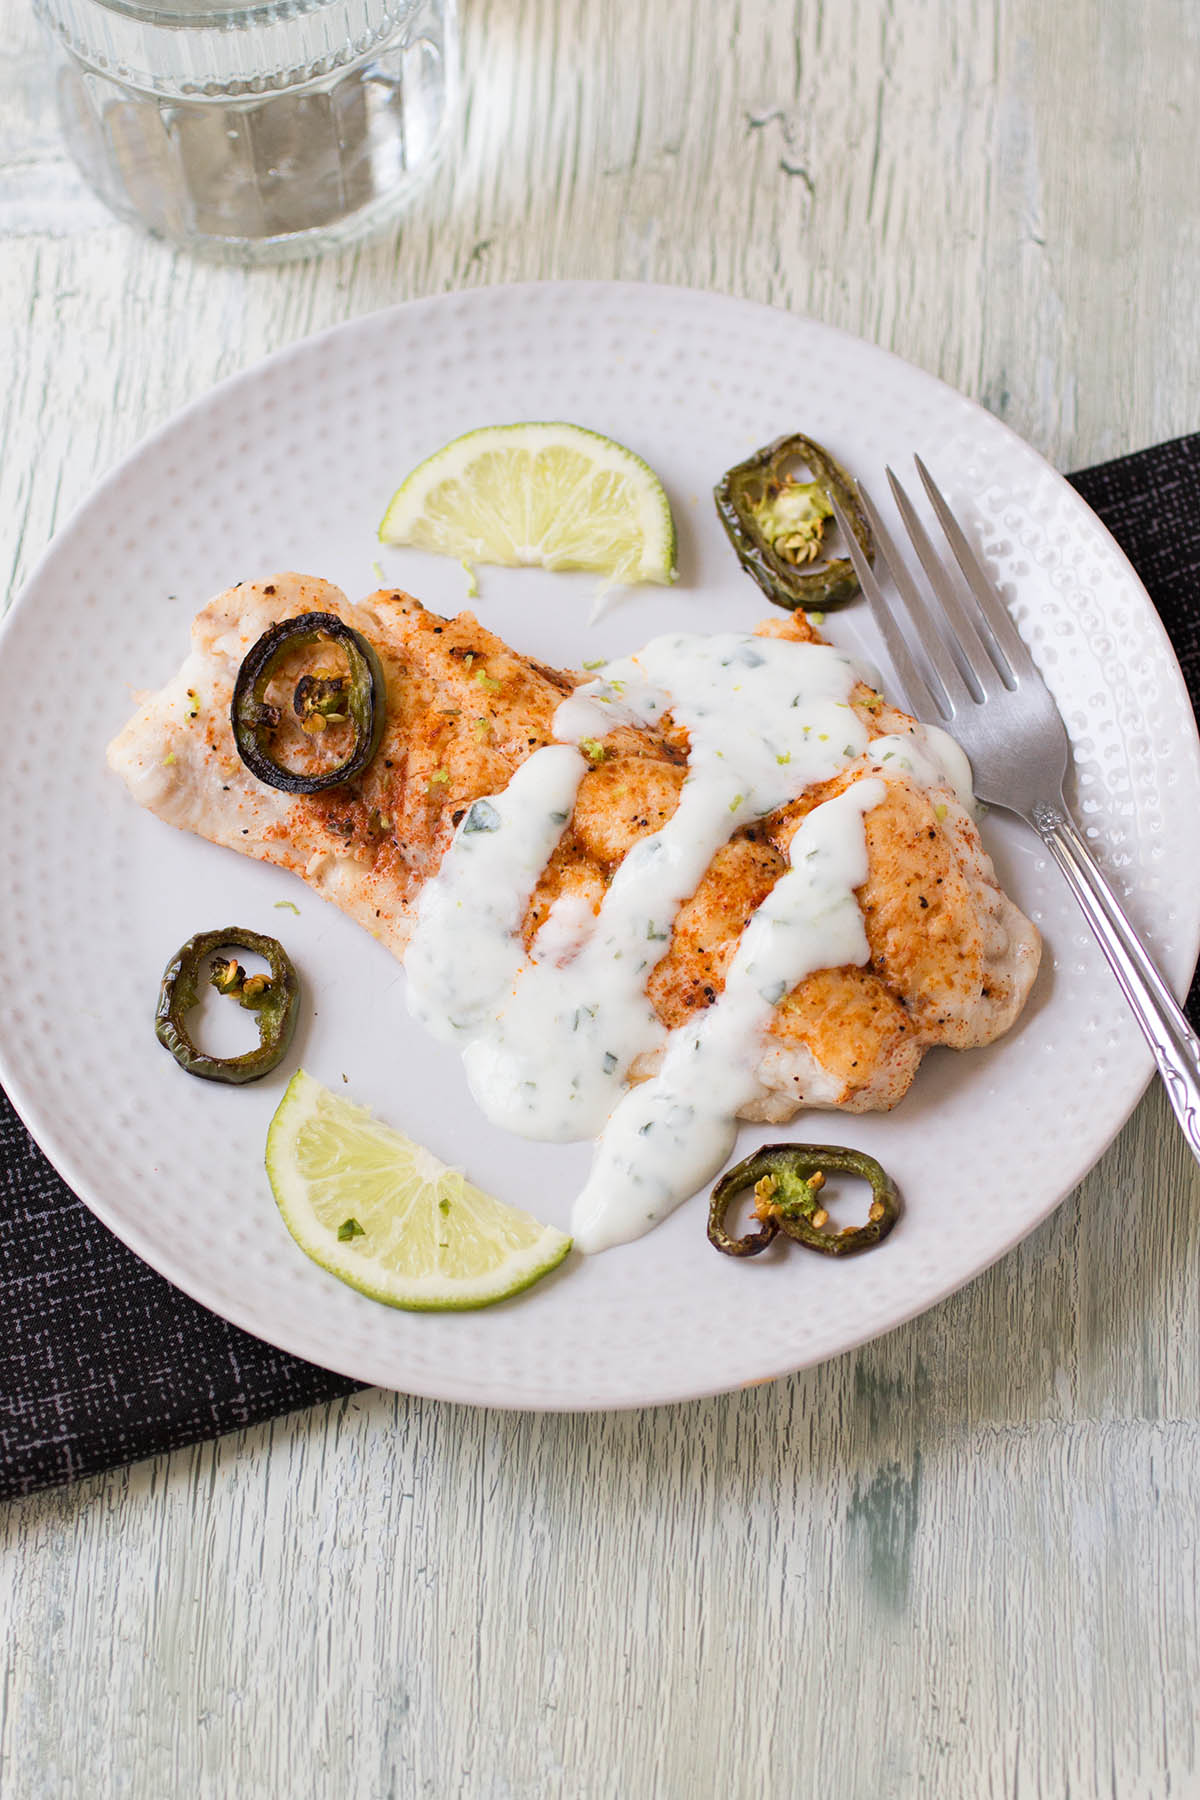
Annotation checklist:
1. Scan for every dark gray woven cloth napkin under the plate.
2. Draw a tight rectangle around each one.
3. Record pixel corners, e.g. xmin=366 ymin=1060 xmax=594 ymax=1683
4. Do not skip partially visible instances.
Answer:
xmin=0 ymin=434 xmax=1200 ymax=1499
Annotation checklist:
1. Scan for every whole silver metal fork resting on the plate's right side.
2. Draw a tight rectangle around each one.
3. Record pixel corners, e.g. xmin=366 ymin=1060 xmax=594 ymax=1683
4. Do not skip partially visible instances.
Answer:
xmin=833 ymin=457 xmax=1200 ymax=1159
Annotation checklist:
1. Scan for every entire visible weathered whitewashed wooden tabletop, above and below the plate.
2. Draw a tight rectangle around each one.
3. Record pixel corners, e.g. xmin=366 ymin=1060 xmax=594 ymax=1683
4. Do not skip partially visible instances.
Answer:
xmin=0 ymin=0 xmax=1200 ymax=1800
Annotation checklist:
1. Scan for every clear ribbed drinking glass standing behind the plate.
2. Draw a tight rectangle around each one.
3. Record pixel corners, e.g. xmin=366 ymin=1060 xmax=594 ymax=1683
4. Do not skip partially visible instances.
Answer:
xmin=34 ymin=0 xmax=457 ymax=261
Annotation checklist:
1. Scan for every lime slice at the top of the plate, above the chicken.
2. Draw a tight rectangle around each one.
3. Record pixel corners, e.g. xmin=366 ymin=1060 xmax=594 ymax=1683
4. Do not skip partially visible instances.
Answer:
xmin=380 ymin=423 xmax=676 ymax=583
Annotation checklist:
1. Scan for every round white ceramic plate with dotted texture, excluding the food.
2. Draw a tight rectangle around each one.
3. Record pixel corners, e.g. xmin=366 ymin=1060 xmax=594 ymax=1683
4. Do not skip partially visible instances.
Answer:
xmin=0 ymin=284 xmax=1200 ymax=1408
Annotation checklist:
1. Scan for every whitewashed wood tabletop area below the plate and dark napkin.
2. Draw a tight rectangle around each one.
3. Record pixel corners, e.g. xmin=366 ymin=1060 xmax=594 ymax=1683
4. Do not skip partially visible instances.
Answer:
xmin=5 ymin=1100 xmax=1200 ymax=1796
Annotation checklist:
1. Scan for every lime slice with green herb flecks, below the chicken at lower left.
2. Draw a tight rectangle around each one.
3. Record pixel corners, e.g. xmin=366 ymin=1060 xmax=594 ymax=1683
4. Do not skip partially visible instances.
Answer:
xmin=266 ymin=1069 xmax=570 ymax=1312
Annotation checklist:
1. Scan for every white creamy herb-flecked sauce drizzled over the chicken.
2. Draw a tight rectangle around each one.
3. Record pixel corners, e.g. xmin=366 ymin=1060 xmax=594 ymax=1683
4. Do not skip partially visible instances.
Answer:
xmin=405 ymin=634 xmax=970 ymax=1249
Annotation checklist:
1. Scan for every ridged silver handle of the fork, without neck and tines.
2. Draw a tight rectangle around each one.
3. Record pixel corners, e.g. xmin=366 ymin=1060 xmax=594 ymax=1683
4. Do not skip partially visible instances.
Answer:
xmin=1033 ymin=805 xmax=1200 ymax=1161
